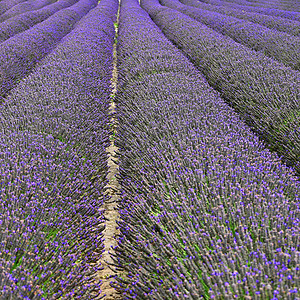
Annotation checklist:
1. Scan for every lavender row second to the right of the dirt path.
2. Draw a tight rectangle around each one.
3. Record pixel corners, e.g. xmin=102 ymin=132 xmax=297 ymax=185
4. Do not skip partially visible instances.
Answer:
xmin=141 ymin=0 xmax=300 ymax=174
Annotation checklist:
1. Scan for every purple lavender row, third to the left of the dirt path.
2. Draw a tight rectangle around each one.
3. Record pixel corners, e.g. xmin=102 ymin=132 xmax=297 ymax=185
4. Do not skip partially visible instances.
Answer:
xmin=0 ymin=0 xmax=78 ymax=43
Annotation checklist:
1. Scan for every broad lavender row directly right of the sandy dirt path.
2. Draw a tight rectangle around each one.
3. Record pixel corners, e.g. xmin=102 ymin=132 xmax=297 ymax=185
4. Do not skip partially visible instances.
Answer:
xmin=114 ymin=0 xmax=300 ymax=300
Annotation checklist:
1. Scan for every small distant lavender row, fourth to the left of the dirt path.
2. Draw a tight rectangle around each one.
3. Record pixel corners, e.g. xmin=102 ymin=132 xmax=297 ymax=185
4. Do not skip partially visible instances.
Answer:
xmin=0 ymin=0 xmax=56 ymax=22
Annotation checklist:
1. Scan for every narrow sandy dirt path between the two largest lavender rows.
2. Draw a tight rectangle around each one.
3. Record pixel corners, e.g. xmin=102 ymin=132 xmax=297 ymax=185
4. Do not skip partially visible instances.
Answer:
xmin=96 ymin=6 xmax=122 ymax=300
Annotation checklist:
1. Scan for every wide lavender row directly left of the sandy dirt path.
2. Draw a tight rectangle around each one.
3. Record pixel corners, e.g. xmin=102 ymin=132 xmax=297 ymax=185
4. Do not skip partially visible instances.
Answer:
xmin=0 ymin=0 xmax=118 ymax=300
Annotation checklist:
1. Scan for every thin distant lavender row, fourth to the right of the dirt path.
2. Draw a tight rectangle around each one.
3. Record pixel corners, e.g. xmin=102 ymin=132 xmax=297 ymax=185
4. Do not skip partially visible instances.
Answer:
xmin=180 ymin=0 xmax=300 ymax=36
